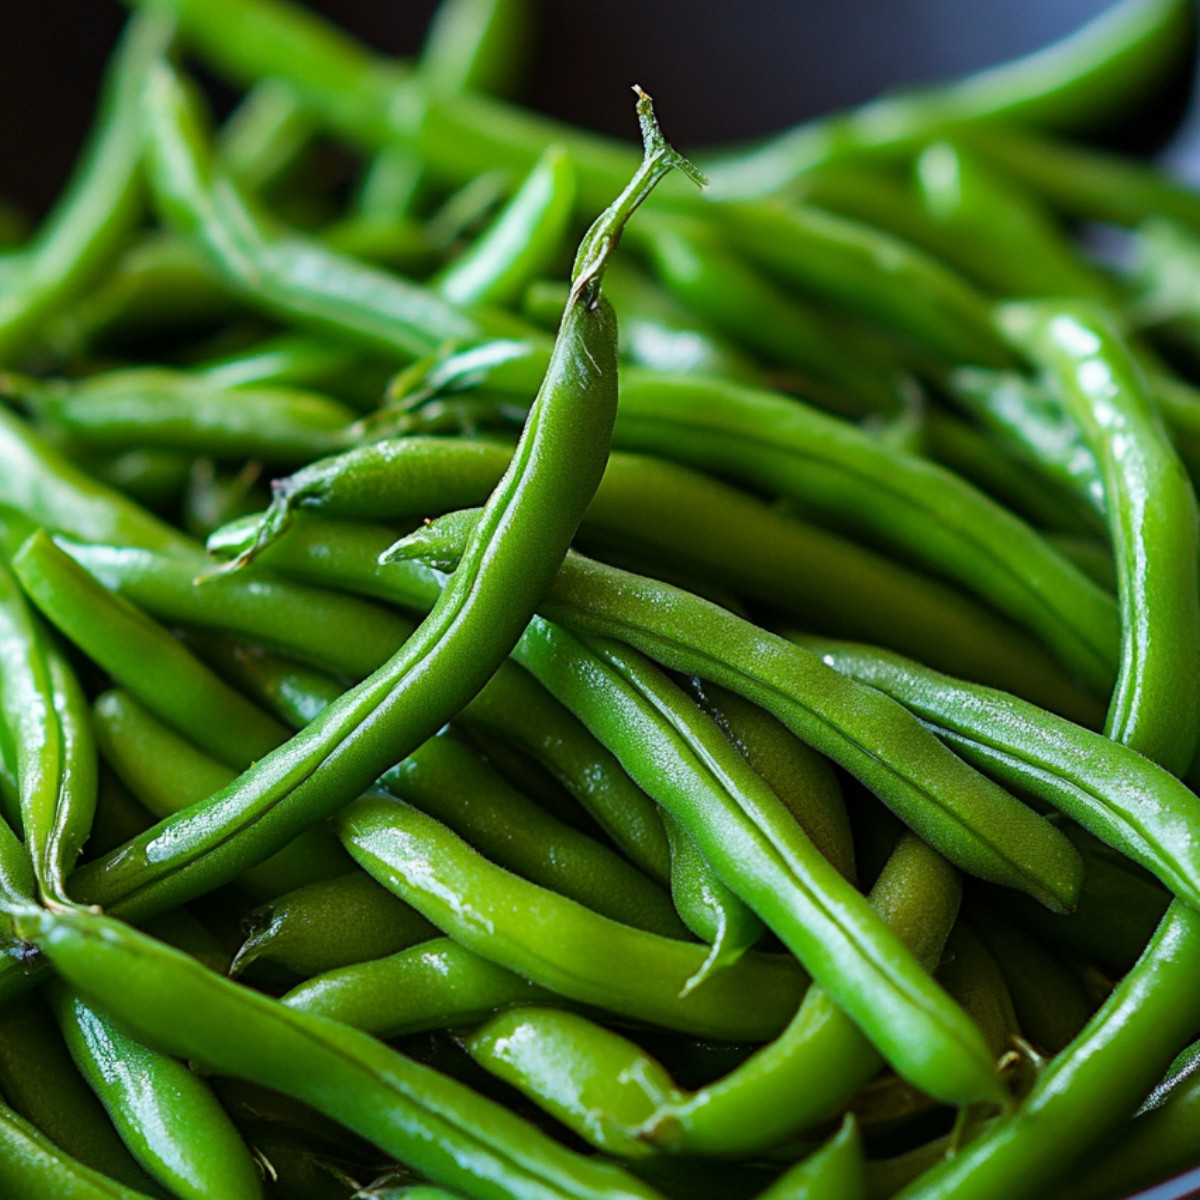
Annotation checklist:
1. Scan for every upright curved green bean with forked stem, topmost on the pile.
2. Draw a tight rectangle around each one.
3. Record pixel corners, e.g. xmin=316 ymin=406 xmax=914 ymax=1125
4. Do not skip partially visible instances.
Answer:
xmin=65 ymin=97 xmax=691 ymax=926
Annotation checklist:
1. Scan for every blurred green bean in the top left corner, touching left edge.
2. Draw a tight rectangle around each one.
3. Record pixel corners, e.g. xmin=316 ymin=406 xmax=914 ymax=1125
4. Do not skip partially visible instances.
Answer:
xmin=0 ymin=12 xmax=175 ymax=361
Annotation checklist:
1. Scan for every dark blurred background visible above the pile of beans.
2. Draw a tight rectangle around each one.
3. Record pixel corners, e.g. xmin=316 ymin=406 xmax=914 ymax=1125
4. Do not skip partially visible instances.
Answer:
xmin=7 ymin=0 xmax=1200 ymax=219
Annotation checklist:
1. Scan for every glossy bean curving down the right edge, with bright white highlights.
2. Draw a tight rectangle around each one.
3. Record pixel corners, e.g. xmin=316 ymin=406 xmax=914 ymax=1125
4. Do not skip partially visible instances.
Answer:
xmin=1000 ymin=301 xmax=1200 ymax=774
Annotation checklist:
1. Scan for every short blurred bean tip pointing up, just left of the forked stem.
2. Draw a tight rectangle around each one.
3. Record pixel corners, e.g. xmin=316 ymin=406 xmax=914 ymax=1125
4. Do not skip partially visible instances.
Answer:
xmin=431 ymin=146 xmax=575 ymax=305
